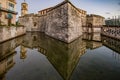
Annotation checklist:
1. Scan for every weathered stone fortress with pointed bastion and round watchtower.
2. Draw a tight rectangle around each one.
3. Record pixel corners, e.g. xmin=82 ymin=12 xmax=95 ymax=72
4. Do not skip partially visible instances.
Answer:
xmin=18 ymin=0 xmax=104 ymax=43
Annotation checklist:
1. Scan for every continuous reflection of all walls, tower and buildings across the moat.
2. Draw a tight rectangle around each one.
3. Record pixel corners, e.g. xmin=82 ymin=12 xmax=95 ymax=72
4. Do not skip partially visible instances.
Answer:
xmin=0 ymin=33 xmax=120 ymax=80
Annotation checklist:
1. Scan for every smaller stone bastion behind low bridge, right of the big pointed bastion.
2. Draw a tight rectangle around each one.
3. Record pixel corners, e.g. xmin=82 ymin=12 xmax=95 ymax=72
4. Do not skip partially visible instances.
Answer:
xmin=83 ymin=14 xmax=105 ymax=33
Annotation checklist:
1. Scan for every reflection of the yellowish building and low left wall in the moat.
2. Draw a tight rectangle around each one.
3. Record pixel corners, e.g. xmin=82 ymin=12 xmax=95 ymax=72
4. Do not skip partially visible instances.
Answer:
xmin=0 ymin=37 xmax=23 ymax=80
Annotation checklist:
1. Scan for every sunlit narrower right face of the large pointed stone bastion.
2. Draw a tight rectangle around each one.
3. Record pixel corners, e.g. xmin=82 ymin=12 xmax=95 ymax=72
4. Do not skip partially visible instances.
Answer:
xmin=68 ymin=4 xmax=82 ymax=42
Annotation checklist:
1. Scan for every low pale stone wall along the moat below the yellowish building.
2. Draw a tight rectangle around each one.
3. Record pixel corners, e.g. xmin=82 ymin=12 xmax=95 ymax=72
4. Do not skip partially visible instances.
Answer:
xmin=0 ymin=26 xmax=26 ymax=43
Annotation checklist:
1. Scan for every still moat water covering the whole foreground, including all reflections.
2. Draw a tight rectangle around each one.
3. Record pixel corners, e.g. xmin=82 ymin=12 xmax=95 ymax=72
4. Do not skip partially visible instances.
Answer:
xmin=0 ymin=33 xmax=120 ymax=80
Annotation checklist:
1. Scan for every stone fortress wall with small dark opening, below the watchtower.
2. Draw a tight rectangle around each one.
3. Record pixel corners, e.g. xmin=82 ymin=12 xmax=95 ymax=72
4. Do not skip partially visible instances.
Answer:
xmin=19 ymin=14 xmax=46 ymax=32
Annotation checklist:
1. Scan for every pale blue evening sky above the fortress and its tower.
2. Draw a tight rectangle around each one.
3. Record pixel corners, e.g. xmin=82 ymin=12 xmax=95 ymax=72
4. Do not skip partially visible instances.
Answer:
xmin=17 ymin=0 xmax=120 ymax=19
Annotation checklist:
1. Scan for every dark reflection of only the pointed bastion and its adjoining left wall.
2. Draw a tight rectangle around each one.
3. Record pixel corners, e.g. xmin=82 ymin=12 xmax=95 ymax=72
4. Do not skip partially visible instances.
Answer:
xmin=22 ymin=33 xmax=86 ymax=80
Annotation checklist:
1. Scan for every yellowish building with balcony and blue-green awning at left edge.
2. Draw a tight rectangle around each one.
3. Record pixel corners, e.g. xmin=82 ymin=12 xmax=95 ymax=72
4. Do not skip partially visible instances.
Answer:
xmin=0 ymin=0 xmax=17 ymax=25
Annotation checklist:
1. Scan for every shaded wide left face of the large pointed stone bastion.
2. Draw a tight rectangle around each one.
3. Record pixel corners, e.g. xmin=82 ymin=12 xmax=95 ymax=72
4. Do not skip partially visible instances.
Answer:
xmin=45 ymin=3 xmax=68 ymax=42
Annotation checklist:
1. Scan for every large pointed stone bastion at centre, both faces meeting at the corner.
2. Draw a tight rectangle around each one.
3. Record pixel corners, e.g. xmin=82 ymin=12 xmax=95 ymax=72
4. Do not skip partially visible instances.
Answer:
xmin=45 ymin=2 xmax=82 ymax=43
